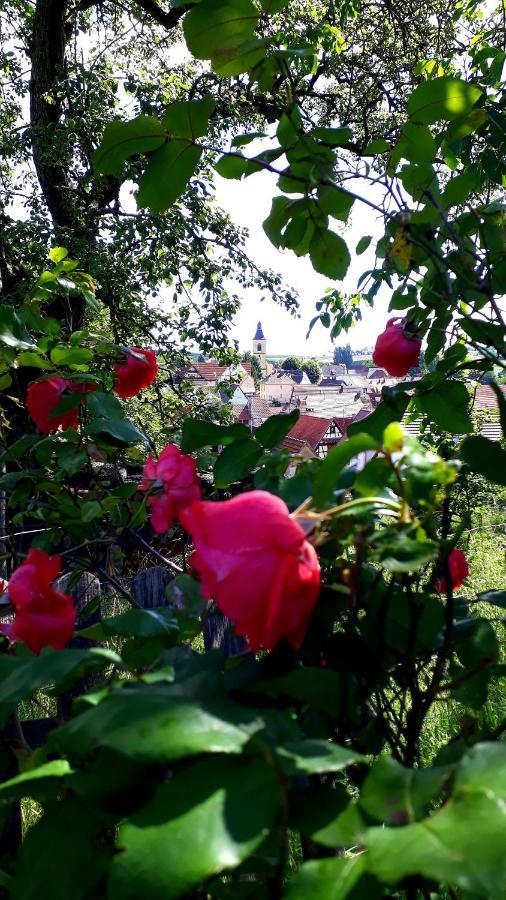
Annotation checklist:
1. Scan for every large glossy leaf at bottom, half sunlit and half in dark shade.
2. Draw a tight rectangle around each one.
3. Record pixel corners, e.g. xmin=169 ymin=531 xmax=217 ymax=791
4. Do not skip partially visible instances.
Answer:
xmin=108 ymin=759 xmax=279 ymax=900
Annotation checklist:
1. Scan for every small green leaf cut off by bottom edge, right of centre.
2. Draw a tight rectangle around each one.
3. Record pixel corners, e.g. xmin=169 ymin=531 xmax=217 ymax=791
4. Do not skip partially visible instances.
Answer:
xmin=283 ymin=854 xmax=382 ymax=900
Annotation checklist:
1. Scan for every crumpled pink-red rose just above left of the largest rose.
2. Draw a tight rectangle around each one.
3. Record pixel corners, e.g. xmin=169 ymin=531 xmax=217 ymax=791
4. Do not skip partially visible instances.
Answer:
xmin=139 ymin=444 xmax=200 ymax=534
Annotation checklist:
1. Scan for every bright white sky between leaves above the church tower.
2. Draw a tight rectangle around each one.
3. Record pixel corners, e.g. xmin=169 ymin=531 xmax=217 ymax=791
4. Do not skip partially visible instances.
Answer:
xmin=216 ymin=172 xmax=388 ymax=356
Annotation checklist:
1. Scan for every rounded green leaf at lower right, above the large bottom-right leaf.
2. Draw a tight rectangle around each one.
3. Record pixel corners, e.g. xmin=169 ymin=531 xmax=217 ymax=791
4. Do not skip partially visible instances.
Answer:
xmin=360 ymin=756 xmax=450 ymax=825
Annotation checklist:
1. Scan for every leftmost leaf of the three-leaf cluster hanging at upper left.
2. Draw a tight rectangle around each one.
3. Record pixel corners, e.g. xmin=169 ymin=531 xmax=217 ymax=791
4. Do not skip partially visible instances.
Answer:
xmin=93 ymin=116 xmax=166 ymax=177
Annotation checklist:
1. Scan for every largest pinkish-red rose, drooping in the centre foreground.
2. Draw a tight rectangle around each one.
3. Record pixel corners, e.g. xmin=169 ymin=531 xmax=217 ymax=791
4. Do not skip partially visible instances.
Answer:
xmin=180 ymin=491 xmax=320 ymax=652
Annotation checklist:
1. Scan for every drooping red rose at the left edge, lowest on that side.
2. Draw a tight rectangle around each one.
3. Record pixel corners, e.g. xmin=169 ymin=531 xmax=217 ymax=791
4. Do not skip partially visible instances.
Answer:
xmin=1 ymin=548 xmax=76 ymax=655
